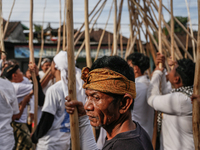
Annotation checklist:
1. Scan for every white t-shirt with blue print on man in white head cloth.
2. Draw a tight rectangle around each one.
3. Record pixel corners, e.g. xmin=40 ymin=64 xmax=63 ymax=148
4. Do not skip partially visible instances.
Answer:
xmin=37 ymin=81 xmax=95 ymax=150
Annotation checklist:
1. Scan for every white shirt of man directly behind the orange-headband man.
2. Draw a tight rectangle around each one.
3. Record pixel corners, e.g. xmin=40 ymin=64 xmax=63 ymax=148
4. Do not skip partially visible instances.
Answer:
xmin=131 ymin=81 xmax=154 ymax=139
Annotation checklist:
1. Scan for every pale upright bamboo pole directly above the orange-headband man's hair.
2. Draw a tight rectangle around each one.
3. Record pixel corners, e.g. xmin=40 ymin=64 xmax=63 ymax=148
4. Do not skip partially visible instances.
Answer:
xmin=113 ymin=0 xmax=117 ymax=55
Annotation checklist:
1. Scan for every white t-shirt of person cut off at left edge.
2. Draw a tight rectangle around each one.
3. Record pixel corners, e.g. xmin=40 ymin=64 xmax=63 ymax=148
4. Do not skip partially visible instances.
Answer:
xmin=0 ymin=78 xmax=19 ymax=150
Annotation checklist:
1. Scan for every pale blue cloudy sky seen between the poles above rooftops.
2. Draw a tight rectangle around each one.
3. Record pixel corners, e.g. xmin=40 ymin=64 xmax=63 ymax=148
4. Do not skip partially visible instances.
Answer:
xmin=2 ymin=0 xmax=198 ymax=39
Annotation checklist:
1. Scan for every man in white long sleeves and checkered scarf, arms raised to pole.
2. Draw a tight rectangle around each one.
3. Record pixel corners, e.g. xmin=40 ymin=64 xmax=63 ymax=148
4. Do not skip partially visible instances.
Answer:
xmin=148 ymin=53 xmax=195 ymax=150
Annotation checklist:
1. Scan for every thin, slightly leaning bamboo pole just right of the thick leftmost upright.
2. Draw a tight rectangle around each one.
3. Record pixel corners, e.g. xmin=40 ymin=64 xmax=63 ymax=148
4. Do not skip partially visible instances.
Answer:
xmin=38 ymin=0 xmax=47 ymax=69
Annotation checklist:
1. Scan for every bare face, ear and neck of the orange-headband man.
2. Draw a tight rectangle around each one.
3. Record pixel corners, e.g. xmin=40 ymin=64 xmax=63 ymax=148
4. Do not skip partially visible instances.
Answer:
xmin=84 ymin=89 xmax=136 ymax=140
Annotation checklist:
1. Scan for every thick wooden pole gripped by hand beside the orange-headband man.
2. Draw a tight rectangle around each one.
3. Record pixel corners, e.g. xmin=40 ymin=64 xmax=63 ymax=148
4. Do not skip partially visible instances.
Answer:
xmin=66 ymin=0 xmax=80 ymax=150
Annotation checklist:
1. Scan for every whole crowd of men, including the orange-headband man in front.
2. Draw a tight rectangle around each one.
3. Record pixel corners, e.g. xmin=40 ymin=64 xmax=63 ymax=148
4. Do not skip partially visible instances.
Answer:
xmin=0 ymin=48 xmax=200 ymax=150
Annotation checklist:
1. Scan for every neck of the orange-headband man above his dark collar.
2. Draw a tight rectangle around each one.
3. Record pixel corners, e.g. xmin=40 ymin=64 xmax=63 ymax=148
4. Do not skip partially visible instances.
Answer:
xmin=104 ymin=113 xmax=136 ymax=140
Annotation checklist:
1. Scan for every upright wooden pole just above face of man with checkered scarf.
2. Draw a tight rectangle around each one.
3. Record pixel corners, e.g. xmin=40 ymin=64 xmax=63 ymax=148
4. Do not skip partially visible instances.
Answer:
xmin=171 ymin=0 xmax=175 ymax=61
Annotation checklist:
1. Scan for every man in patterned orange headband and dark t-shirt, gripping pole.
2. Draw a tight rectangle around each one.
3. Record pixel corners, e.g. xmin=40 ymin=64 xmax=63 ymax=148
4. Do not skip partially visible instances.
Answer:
xmin=66 ymin=56 xmax=153 ymax=150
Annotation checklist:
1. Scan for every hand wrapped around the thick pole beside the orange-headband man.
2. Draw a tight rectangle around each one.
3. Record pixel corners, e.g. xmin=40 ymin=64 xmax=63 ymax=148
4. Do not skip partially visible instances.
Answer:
xmin=65 ymin=96 xmax=86 ymax=117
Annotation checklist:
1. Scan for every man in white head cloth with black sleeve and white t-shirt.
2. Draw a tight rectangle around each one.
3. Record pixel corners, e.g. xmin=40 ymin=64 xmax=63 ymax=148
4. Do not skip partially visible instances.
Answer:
xmin=32 ymin=51 xmax=96 ymax=150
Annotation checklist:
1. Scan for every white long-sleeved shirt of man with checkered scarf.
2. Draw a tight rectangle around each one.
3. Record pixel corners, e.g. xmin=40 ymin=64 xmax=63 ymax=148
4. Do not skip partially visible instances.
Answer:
xmin=148 ymin=70 xmax=194 ymax=150
